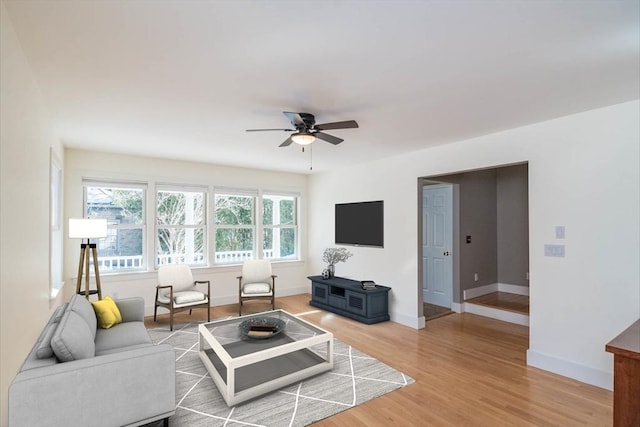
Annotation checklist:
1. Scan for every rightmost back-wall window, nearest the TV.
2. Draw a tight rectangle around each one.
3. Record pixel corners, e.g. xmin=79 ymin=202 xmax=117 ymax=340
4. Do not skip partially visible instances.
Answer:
xmin=262 ymin=194 xmax=298 ymax=259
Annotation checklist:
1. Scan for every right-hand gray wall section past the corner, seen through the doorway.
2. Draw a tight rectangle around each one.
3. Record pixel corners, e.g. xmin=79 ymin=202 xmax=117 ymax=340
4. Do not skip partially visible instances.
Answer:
xmin=496 ymin=164 xmax=529 ymax=286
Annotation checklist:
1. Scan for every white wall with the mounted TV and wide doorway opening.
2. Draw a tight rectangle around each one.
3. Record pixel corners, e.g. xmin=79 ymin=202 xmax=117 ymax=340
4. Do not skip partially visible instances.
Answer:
xmin=309 ymin=101 xmax=640 ymax=388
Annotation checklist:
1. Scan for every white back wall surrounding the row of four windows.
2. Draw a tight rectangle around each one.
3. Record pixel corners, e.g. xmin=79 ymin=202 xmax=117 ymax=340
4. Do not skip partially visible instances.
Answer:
xmin=65 ymin=148 xmax=310 ymax=315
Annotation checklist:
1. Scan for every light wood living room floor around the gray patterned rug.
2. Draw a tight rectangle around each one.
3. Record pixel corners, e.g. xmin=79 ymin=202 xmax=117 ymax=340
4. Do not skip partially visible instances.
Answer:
xmin=145 ymin=295 xmax=613 ymax=427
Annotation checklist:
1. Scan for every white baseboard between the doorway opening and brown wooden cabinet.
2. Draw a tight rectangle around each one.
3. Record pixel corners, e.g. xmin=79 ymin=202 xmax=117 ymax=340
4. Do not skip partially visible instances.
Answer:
xmin=527 ymin=349 xmax=613 ymax=390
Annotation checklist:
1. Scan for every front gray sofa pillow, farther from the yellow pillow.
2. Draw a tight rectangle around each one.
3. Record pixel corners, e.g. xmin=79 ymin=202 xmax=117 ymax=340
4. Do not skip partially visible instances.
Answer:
xmin=51 ymin=310 xmax=96 ymax=362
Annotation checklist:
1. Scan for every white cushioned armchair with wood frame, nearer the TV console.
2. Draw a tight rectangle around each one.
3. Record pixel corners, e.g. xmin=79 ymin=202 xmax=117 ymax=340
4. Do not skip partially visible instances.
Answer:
xmin=237 ymin=259 xmax=278 ymax=316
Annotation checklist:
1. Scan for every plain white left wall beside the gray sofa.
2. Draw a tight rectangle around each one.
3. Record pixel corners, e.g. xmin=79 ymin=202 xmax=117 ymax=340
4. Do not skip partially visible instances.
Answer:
xmin=0 ymin=3 xmax=62 ymax=426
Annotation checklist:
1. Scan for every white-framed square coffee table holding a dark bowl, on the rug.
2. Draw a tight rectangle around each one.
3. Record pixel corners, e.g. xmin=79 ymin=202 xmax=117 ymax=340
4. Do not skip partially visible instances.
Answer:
xmin=198 ymin=310 xmax=333 ymax=406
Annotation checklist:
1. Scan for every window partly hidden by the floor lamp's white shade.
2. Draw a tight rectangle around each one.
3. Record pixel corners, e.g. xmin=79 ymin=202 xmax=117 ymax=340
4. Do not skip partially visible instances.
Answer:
xmin=84 ymin=183 xmax=145 ymax=272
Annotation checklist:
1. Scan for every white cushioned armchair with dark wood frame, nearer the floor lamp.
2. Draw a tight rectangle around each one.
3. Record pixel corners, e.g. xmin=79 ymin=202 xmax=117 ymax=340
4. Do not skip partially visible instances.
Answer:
xmin=153 ymin=264 xmax=211 ymax=331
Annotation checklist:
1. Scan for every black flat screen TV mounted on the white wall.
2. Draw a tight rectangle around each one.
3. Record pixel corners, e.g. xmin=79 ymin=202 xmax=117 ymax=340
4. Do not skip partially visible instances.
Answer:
xmin=335 ymin=200 xmax=384 ymax=248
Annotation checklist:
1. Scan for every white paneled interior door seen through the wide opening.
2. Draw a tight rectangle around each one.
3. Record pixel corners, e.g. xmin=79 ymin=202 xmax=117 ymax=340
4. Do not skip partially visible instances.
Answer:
xmin=422 ymin=184 xmax=453 ymax=308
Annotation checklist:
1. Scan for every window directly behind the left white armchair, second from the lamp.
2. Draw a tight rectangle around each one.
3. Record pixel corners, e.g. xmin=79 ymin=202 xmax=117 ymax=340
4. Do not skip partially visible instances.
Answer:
xmin=156 ymin=188 xmax=207 ymax=265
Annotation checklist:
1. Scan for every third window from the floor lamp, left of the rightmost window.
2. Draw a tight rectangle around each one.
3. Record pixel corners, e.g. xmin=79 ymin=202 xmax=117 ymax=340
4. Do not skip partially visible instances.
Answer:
xmin=213 ymin=192 xmax=256 ymax=264
